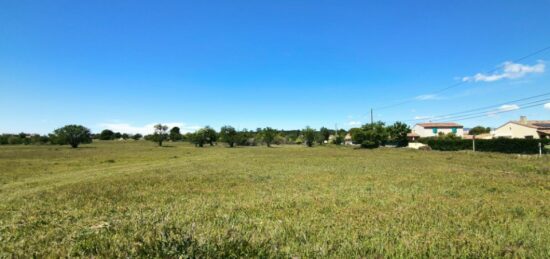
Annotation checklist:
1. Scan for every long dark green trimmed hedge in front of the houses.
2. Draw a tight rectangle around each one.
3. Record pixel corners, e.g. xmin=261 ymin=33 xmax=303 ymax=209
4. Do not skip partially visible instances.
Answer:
xmin=419 ymin=138 xmax=550 ymax=154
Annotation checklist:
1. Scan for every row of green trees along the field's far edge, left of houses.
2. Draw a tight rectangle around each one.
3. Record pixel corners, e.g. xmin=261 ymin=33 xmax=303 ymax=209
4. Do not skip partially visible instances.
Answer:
xmin=0 ymin=122 xmax=410 ymax=148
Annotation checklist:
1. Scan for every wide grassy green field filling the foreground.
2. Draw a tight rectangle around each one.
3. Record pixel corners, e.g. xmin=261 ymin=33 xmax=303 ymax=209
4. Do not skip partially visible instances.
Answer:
xmin=0 ymin=141 xmax=550 ymax=258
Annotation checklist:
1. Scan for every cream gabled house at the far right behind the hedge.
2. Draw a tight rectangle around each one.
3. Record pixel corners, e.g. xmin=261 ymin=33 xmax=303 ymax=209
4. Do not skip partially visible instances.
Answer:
xmin=494 ymin=116 xmax=550 ymax=139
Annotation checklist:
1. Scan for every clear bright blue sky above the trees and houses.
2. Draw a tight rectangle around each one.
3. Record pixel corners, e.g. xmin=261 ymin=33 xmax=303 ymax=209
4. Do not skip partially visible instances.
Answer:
xmin=0 ymin=0 xmax=550 ymax=133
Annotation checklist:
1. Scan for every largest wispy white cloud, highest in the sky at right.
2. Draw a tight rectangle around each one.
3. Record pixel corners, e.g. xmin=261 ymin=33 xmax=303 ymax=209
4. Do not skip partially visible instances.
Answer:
xmin=462 ymin=61 xmax=545 ymax=82
